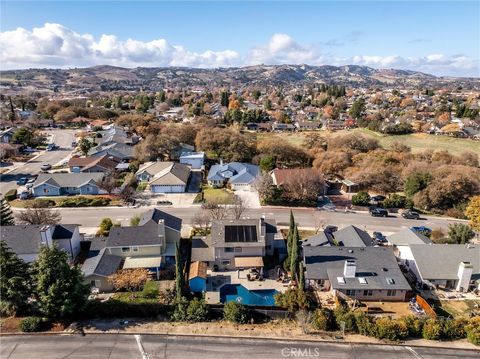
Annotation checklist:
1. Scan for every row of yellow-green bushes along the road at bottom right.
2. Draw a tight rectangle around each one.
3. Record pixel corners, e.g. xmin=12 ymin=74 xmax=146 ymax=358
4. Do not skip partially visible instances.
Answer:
xmin=312 ymin=308 xmax=480 ymax=345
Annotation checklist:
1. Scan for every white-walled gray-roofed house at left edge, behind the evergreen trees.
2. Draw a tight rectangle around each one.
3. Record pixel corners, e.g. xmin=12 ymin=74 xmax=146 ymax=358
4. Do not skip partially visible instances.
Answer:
xmin=0 ymin=224 xmax=83 ymax=263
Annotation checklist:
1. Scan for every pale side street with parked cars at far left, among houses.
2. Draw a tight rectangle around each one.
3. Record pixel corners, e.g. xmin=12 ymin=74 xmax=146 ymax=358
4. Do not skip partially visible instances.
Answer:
xmin=0 ymin=130 xmax=75 ymax=193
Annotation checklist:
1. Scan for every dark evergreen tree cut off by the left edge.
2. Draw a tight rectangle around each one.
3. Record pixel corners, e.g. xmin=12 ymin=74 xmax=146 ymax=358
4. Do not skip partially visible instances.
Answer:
xmin=0 ymin=241 xmax=31 ymax=315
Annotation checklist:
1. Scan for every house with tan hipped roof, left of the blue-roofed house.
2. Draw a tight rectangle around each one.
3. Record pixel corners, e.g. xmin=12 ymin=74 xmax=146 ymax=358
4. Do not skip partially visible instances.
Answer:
xmin=135 ymin=161 xmax=190 ymax=193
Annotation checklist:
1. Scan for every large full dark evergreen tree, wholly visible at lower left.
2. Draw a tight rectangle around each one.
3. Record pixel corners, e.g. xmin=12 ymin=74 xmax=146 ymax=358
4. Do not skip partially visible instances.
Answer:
xmin=33 ymin=246 xmax=90 ymax=318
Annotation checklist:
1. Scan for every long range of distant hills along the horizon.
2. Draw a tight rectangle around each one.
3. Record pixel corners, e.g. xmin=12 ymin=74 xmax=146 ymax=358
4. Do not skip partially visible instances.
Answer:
xmin=0 ymin=65 xmax=480 ymax=93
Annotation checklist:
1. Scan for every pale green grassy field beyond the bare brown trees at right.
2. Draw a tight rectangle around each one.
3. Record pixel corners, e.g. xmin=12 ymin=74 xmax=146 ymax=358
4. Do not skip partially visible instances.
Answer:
xmin=257 ymin=128 xmax=480 ymax=155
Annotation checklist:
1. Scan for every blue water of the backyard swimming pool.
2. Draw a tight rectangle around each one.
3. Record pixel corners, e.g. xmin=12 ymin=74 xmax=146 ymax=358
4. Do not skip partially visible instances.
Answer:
xmin=220 ymin=284 xmax=278 ymax=306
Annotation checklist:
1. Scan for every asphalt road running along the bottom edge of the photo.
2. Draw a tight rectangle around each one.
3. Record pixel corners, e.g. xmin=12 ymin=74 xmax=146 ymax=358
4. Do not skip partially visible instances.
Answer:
xmin=0 ymin=334 xmax=480 ymax=359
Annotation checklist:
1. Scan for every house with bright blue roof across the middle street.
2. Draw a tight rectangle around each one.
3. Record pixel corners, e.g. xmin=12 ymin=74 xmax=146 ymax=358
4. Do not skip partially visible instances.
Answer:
xmin=207 ymin=162 xmax=260 ymax=191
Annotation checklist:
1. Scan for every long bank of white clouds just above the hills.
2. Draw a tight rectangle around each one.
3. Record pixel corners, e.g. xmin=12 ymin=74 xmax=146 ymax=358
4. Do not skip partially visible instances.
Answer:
xmin=0 ymin=23 xmax=479 ymax=76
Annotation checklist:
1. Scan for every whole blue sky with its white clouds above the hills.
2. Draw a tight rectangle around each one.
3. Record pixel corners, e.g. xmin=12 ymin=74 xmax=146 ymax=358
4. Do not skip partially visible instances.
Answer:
xmin=0 ymin=1 xmax=480 ymax=77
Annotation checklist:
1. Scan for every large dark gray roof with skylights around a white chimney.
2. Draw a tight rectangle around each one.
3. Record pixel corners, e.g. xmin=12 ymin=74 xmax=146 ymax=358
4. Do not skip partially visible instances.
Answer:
xmin=303 ymin=246 xmax=410 ymax=290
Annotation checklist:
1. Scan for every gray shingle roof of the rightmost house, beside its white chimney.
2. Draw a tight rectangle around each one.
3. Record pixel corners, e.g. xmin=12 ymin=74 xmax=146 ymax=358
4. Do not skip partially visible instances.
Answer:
xmin=410 ymin=244 xmax=480 ymax=280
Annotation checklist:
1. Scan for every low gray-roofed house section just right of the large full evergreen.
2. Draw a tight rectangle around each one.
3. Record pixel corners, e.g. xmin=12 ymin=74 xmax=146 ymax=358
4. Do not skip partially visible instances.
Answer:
xmin=82 ymin=248 xmax=124 ymax=292
